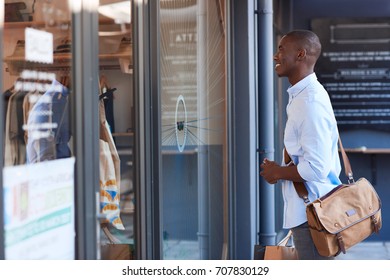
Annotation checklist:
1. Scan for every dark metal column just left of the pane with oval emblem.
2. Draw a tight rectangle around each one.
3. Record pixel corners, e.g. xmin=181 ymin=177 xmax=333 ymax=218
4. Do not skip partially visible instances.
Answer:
xmin=132 ymin=0 xmax=163 ymax=260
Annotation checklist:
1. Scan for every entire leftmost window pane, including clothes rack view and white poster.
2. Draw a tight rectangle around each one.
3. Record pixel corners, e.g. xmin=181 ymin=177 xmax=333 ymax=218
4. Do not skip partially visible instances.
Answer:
xmin=2 ymin=0 xmax=75 ymax=259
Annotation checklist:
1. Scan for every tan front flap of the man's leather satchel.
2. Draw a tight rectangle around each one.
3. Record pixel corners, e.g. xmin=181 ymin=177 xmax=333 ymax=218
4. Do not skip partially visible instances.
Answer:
xmin=308 ymin=178 xmax=381 ymax=234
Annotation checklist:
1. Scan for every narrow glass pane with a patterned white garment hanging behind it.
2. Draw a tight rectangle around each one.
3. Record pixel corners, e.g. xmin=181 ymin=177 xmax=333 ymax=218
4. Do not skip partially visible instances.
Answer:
xmin=98 ymin=0 xmax=135 ymax=259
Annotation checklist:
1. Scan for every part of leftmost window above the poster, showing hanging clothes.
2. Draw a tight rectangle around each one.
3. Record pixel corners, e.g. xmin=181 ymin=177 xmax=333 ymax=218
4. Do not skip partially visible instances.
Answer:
xmin=3 ymin=1 xmax=72 ymax=166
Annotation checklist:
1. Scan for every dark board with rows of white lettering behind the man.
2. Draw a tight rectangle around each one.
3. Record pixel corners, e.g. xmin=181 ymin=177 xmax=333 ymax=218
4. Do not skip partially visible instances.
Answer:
xmin=311 ymin=18 xmax=390 ymax=131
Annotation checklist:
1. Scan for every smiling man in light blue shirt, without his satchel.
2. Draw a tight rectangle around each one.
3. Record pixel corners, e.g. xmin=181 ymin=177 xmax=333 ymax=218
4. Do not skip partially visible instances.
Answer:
xmin=260 ymin=30 xmax=341 ymax=260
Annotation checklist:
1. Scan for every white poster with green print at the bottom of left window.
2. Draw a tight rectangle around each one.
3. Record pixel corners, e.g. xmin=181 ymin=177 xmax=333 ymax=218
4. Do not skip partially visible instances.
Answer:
xmin=3 ymin=158 xmax=75 ymax=260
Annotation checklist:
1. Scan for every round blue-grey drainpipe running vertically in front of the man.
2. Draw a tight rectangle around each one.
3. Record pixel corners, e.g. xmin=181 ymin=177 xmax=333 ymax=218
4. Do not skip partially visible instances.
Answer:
xmin=256 ymin=0 xmax=276 ymax=245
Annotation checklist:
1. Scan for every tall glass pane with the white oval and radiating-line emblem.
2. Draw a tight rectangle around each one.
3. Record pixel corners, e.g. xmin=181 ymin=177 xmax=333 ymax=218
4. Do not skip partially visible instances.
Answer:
xmin=160 ymin=0 xmax=227 ymax=259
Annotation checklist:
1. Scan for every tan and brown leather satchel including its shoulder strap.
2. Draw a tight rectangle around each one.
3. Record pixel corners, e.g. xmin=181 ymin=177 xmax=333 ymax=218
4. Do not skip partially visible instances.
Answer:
xmin=284 ymin=138 xmax=382 ymax=257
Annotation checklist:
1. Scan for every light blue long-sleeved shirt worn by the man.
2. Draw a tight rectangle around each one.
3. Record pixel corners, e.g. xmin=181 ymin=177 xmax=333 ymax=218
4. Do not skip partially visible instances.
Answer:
xmin=282 ymin=73 xmax=341 ymax=228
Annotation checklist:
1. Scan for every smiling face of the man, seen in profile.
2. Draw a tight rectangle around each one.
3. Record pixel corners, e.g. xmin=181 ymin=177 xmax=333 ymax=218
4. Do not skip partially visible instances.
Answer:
xmin=274 ymin=36 xmax=298 ymax=77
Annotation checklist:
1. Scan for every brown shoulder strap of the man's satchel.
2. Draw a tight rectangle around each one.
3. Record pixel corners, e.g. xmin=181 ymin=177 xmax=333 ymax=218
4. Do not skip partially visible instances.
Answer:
xmin=284 ymin=137 xmax=354 ymax=204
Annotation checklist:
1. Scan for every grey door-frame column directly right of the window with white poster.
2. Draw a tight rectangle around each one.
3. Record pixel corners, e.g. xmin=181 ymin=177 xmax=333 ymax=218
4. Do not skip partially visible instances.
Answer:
xmin=70 ymin=0 xmax=99 ymax=259
